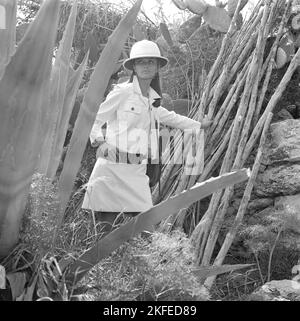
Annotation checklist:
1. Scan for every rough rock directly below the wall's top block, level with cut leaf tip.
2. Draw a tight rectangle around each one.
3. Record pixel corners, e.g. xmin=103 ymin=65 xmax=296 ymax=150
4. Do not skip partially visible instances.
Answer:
xmin=254 ymin=164 xmax=300 ymax=198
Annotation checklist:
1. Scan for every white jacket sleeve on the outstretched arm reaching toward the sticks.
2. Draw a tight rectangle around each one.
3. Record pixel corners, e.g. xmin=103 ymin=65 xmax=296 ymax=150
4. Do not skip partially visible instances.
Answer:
xmin=157 ymin=107 xmax=201 ymax=130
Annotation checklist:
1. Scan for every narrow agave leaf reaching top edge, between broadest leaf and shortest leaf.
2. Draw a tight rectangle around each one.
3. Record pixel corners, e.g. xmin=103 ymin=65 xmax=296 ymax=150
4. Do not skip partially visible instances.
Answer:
xmin=40 ymin=1 xmax=77 ymax=178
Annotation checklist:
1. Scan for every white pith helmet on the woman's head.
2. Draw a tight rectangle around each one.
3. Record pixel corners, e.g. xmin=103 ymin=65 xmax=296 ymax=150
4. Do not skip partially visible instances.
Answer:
xmin=123 ymin=39 xmax=169 ymax=70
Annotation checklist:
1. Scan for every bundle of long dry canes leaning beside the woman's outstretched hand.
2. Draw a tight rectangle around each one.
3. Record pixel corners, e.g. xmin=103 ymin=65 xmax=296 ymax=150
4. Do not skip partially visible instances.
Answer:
xmin=153 ymin=0 xmax=300 ymax=286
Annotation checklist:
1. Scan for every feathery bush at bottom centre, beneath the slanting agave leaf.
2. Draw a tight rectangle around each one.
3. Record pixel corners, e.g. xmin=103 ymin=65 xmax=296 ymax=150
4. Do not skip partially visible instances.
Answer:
xmin=76 ymin=230 xmax=208 ymax=301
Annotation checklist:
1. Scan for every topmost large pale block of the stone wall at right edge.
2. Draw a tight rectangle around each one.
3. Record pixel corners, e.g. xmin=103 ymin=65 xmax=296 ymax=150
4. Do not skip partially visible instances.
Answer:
xmin=264 ymin=119 xmax=300 ymax=165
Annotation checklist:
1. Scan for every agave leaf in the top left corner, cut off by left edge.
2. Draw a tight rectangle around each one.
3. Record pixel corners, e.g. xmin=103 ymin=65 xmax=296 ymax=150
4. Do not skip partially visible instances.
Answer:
xmin=0 ymin=0 xmax=17 ymax=79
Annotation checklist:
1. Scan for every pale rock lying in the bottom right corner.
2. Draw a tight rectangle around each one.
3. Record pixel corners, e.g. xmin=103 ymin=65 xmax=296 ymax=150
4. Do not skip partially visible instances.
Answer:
xmin=249 ymin=280 xmax=300 ymax=301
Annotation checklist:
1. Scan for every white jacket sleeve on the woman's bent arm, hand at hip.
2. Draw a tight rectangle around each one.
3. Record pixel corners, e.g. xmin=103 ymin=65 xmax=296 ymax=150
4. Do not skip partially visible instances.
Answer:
xmin=90 ymin=88 xmax=122 ymax=146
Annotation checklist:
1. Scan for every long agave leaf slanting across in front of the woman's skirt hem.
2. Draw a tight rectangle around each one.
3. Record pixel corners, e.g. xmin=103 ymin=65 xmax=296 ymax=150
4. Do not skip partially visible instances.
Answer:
xmin=66 ymin=169 xmax=250 ymax=284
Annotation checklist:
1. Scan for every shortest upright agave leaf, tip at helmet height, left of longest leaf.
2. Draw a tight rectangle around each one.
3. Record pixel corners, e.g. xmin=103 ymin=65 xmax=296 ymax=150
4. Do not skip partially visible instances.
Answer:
xmin=50 ymin=52 xmax=89 ymax=173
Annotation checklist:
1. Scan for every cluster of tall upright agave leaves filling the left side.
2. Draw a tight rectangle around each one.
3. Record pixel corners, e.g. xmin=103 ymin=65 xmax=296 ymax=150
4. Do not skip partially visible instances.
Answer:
xmin=0 ymin=0 xmax=142 ymax=257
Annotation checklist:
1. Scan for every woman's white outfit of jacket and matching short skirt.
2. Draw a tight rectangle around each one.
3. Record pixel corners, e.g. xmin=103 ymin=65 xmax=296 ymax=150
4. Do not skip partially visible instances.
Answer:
xmin=82 ymin=77 xmax=201 ymax=212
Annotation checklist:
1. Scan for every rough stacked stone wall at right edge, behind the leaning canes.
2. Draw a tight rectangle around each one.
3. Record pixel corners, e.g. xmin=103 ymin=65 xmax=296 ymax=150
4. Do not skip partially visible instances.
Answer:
xmin=227 ymin=118 xmax=300 ymax=254
